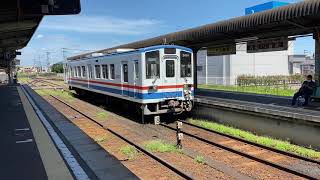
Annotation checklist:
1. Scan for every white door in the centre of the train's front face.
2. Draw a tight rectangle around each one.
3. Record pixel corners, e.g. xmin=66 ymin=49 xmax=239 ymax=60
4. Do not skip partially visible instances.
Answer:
xmin=163 ymin=58 xmax=178 ymax=98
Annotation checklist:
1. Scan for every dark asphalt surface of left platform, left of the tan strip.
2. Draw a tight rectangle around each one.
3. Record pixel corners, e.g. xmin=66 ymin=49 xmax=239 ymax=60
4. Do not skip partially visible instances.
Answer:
xmin=0 ymin=86 xmax=47 ymax=180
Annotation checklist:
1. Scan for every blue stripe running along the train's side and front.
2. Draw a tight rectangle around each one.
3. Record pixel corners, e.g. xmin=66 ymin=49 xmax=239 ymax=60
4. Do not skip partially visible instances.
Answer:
xmin=69 ymin=82 xmax=182 ymax=99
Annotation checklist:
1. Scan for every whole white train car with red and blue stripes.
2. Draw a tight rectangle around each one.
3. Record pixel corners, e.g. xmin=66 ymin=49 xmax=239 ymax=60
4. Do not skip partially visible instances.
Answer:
xmin=65 ymin=45 xmax=194 ymax=115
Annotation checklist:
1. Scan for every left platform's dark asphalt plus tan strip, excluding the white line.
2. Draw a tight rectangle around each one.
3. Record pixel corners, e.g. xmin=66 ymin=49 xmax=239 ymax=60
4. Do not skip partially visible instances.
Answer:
xmin=0 ymin=85 xmax=73 ymax=180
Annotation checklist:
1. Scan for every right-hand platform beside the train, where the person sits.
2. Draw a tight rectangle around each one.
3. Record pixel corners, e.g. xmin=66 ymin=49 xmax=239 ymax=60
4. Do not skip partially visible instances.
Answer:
xmin=196 ymin=89 xmax=320 ymax=123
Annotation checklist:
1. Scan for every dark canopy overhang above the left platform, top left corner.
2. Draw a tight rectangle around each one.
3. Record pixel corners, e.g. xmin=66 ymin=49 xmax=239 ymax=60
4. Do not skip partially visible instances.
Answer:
xmin=0 ymin=0 xmax=81 ymax=68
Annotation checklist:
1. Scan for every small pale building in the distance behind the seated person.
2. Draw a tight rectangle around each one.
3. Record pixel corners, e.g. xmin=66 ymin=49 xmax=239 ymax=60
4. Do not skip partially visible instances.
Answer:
xmin=289 ymin=55 xmax=315 ymax=75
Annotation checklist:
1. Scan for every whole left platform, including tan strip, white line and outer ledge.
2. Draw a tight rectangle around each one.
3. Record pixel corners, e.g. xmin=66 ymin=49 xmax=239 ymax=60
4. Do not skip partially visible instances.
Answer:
xmin=0 ymin=85 xmax=138 ymax=180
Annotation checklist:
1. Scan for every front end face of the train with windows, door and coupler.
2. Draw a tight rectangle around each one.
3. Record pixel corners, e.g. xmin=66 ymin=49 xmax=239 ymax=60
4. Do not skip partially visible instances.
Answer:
xmin=141 ymin=45 xmax=194 ymax=115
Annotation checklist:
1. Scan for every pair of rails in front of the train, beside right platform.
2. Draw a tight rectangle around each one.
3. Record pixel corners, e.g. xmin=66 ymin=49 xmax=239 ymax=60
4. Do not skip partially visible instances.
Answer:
xmin=160 ymin=121 xmax=320 ymax=179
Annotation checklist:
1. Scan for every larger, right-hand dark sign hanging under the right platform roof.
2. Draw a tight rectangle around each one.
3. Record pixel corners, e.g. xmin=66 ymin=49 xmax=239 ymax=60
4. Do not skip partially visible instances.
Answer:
xmin=247 ymin=37 xmax=289 ymax=53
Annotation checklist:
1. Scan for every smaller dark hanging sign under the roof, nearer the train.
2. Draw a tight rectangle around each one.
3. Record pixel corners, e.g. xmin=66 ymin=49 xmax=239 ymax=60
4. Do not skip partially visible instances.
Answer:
xmin=207 ymin=44 xmax=237 ymax=56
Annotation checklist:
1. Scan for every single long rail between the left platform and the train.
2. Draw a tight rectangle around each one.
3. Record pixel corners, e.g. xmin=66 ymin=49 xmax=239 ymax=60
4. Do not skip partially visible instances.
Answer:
xmin=51 ymin=95 xmax=193 ymax=179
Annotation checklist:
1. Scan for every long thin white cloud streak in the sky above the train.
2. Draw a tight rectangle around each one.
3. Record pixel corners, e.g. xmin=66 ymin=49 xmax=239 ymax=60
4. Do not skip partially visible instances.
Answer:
xmin=40 ymin=15 xmax=161 ymax=35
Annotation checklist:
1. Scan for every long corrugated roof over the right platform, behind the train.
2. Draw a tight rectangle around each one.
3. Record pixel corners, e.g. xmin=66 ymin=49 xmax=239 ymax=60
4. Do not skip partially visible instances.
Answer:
xmin=68 ymin=0 xmax=320 ymax=60
